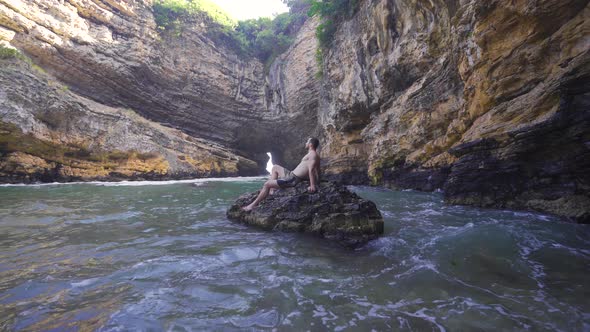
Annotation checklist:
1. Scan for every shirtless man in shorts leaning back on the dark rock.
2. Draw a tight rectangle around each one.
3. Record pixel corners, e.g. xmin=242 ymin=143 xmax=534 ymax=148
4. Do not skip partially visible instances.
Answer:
xmin=242 ymin=138 xmax=320 ymax=211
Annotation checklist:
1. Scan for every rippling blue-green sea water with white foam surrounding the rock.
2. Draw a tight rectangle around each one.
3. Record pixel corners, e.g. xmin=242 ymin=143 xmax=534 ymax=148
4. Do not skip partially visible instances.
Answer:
xmin=0 ymin=178 xmax=590 ymax=331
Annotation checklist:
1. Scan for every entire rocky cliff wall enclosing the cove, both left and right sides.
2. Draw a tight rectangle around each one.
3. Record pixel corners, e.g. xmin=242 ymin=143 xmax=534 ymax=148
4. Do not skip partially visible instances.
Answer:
xmin=0 ymin=0 xmax=590 ymax=222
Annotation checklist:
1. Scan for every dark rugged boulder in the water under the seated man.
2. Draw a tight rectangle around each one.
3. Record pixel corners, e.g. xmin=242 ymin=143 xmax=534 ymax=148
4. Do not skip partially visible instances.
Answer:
xmin=227 ymin=182 xmax=383 ymax=247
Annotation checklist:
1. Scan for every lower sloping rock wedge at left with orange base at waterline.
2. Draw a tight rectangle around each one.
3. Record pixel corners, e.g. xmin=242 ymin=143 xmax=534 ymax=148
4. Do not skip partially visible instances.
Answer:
xmin=0 ymin=58 xmax=258 ymax=183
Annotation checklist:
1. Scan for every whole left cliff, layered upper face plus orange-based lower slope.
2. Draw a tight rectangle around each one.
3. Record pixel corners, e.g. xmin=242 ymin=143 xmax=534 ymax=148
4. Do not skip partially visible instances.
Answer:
xmin=0 ymin=0 xmax=266 ymax=181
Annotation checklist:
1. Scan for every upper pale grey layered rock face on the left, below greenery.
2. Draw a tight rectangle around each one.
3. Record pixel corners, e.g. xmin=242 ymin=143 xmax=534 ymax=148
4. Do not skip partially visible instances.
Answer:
xmin=0 ymin=0 xmax=264 ymax=145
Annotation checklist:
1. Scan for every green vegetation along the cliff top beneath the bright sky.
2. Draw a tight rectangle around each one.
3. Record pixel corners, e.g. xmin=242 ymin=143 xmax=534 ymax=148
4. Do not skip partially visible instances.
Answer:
xmin=153 ymin=0 xmax=358 ymax=66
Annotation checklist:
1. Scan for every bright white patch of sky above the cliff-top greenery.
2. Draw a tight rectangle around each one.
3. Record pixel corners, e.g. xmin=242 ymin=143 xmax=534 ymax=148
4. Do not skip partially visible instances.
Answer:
xmin=211 ymin=0 xmax=289 ymax=21
